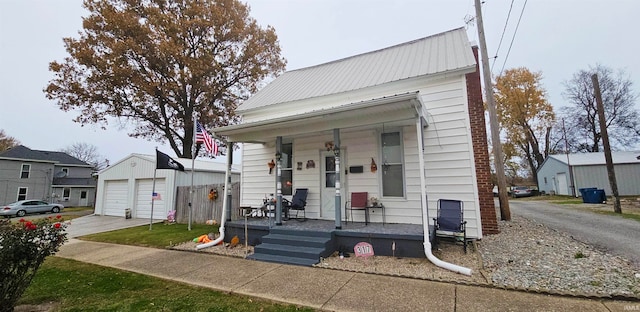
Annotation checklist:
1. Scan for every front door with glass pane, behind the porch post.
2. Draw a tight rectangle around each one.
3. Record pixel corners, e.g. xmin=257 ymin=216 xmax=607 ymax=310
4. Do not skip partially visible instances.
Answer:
xmin=320 ymin=150 xmax=346 ymax=220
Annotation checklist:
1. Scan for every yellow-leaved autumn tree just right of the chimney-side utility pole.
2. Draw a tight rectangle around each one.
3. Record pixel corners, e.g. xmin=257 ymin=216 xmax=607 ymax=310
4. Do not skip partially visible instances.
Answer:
xmin=495 ymin=67 xmax=555 ymax=184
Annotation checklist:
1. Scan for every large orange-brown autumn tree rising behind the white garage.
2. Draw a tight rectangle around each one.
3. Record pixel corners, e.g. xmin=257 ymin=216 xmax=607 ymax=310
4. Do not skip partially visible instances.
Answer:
xmin=44 ymin=0 xmax=286 ymax=158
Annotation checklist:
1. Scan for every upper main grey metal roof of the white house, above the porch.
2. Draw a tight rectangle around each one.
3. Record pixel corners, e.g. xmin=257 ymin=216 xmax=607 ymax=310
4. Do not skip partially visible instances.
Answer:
xmin=237 ymin=28 xmax=476 ymax=112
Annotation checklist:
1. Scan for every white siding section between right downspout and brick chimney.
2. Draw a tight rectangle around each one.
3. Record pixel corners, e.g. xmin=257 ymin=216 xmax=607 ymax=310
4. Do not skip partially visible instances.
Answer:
xmin=420 ymin=78 xmax=482 ymax=237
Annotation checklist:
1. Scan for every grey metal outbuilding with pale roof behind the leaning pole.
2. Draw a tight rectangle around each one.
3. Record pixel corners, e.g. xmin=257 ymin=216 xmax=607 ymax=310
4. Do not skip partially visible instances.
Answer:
xmin=537 ymin=152 xmax=640 ymax=197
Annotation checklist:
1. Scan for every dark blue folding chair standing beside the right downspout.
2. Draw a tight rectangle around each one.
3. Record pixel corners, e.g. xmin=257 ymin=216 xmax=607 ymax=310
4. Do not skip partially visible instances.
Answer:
xmin=433 ymin=199 xmax=467 ymax=253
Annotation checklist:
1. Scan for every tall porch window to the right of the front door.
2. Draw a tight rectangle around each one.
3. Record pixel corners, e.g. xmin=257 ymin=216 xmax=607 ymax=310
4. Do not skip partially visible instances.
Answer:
xmin=381 ymin=131 xmax=404 ymax=197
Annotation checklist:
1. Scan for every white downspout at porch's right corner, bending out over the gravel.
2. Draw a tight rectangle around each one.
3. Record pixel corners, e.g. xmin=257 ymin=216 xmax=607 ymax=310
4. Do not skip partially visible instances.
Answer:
xmin=414 ymin=102 xmax=471 ymax=275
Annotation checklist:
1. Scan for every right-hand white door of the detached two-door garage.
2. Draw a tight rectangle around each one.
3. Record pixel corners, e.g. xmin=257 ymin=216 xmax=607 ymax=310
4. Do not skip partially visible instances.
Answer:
xmin=133 ymin=179 xmax=167 ymax=220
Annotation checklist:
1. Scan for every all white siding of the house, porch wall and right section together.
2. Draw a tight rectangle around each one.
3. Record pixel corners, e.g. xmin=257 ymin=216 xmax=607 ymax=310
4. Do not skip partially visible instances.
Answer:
xmin=236 ymin=76 xmax=481 ymax=237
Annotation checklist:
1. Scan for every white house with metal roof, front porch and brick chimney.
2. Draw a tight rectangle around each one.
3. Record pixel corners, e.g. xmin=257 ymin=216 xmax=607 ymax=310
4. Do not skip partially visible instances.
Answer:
xmin=213 ymin=28 xmax=497 ymax=238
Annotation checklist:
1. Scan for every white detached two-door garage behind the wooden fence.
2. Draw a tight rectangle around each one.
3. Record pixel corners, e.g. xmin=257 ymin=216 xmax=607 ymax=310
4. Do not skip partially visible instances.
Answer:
xmin=95 ymin=154 xmax=240 ymax=220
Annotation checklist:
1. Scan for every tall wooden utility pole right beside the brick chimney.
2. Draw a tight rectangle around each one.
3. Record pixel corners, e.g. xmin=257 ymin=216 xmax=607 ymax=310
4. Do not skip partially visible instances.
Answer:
xmin=475 ymin=0 xmax=511 ymax=221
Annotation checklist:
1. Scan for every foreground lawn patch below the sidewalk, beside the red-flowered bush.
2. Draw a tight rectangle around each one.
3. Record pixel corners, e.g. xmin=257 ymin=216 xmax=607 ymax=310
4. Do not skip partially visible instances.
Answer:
xmin=18 ymin=257 xmax=314 ymax=312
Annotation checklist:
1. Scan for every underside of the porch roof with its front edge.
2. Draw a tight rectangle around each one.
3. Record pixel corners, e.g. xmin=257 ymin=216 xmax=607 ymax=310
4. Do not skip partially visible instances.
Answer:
xmin=213 ymin=92 xmax=426 ymax=143
